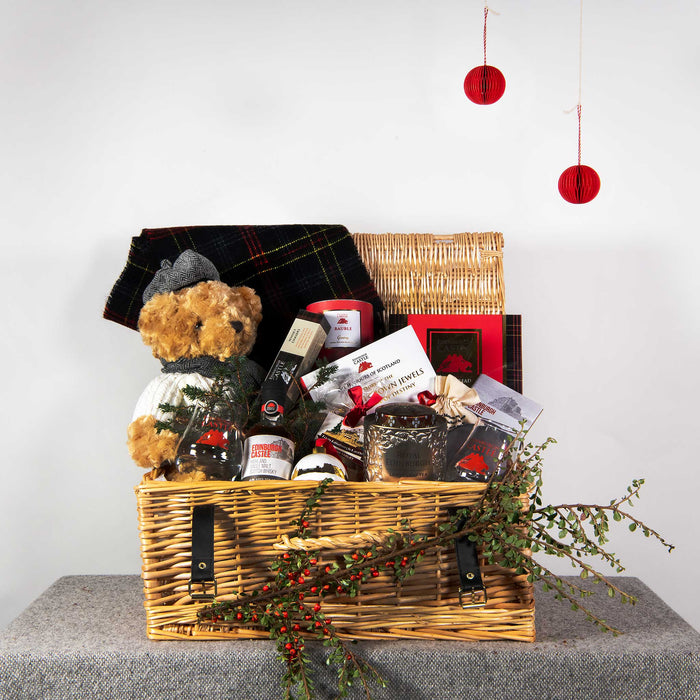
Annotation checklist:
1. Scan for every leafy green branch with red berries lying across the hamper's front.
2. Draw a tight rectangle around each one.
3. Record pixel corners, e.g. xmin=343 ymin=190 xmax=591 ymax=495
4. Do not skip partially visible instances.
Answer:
xmin=199 ymin=432 xmax=674 ymax=700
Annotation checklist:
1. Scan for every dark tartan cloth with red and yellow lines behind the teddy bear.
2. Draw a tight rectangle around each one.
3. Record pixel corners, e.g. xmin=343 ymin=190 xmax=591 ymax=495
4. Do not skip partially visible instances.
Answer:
xmin=103 ymin=224 xmax=383 ymax=367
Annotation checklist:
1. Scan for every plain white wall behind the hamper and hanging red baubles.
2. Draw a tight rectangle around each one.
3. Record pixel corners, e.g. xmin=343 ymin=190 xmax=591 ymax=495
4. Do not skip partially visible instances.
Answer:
xmin=0 ymin=0 xmax=700 ymax=628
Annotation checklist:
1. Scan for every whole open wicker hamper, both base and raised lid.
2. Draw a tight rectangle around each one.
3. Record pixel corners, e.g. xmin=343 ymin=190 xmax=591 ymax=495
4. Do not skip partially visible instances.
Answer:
xmin=136 ymin=233 xmax=535 ymax=641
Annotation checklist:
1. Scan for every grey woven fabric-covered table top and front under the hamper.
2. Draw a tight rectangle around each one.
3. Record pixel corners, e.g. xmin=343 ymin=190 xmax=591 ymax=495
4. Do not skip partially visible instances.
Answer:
xmin=0 ymin=576 xmax=700 ymax=700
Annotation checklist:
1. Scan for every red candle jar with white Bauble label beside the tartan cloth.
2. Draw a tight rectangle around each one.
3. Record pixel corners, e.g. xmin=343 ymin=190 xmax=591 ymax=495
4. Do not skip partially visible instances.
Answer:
xmin=306 ymin=299 xmax=374 ymax=362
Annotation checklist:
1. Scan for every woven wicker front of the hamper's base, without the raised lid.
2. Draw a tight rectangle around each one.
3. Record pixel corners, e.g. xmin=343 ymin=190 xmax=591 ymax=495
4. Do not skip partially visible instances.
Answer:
xmin=136 ymin=478 xmax=535 ymax=641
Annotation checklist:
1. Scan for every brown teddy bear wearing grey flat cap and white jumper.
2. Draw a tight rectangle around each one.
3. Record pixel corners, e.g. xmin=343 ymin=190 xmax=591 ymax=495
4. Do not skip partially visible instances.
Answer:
xmin=127 ymin=250 xmax=264 ymax=480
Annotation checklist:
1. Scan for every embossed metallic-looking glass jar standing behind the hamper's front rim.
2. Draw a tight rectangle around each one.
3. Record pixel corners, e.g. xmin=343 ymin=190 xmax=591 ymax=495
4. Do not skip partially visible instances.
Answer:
xmin=363 ymin=402 xmax=447 ymax=481
